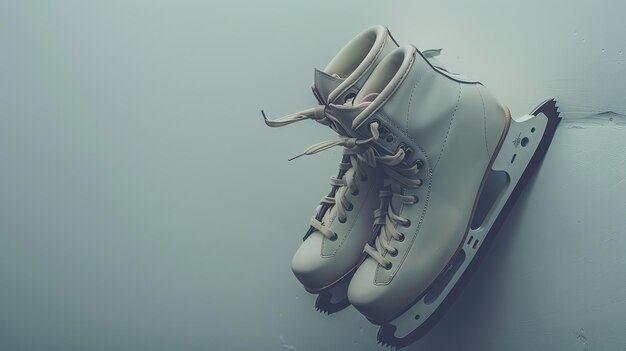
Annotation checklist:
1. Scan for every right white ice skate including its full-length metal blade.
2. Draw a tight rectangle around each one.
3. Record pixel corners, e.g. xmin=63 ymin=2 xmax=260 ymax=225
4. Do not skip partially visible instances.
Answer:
xmin=329 ymin=46 xmax=559 ymax=347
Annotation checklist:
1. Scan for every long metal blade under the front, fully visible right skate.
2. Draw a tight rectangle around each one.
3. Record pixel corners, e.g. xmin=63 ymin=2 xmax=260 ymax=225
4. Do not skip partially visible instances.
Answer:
xmin=378 ymin=99 xmax=560 ymax=349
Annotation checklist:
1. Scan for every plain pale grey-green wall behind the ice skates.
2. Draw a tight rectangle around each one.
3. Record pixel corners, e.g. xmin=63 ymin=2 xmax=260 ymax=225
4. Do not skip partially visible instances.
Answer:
xmin=0 ymin=0 xmax=626 ymax=351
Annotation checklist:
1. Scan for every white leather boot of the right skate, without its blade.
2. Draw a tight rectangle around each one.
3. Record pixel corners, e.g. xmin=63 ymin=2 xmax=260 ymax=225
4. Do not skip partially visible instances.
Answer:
xmin=348 ymin=42 xmax=510 ymax=321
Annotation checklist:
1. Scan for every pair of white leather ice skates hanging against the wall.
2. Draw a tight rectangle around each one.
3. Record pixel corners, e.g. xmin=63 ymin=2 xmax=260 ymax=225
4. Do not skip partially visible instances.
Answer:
xmin=263 ymin=26 xmax=560 ymax=347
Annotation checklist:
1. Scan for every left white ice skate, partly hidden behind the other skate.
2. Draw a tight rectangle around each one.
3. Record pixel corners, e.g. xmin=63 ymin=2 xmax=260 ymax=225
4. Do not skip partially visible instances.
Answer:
xmin=263 ymin=26 xmax=398 ymax=313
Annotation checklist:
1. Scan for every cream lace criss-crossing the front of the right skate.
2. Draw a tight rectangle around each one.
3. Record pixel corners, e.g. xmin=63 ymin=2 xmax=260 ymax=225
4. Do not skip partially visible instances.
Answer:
xmin=364 ymin=148 xmax=422 ymax=269
